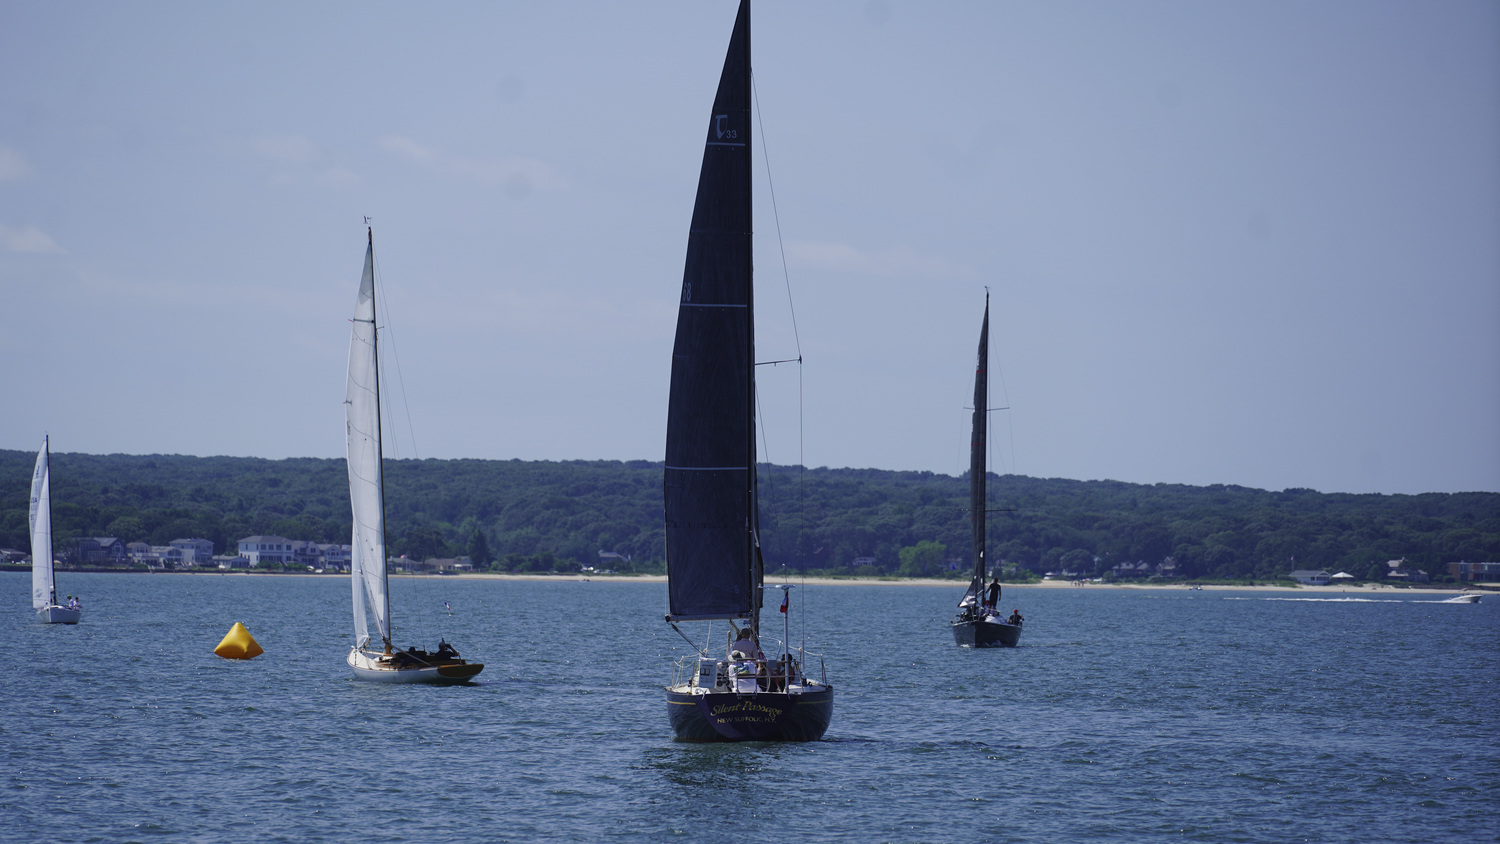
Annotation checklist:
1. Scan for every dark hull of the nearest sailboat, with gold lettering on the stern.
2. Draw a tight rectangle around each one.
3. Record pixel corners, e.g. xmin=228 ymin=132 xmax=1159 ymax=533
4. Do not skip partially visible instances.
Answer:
xmin=666 ymin=687 xmax=834 ymax=742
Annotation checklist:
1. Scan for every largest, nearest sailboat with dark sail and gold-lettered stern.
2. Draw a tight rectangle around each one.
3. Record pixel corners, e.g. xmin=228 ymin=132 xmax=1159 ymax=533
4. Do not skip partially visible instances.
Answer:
xmin=663 ymin=0 xmax=834 ymax=742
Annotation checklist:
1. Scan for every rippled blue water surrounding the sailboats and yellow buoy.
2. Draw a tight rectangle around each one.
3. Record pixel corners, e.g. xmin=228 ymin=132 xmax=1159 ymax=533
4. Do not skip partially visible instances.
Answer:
xmin=0 ymin=573 xmax=1500 ymax=843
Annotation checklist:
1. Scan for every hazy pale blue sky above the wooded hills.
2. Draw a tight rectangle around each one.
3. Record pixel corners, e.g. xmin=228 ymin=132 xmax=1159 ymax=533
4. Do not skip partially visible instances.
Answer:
xmin=0 ymin=0 xmax=1500 ymax=493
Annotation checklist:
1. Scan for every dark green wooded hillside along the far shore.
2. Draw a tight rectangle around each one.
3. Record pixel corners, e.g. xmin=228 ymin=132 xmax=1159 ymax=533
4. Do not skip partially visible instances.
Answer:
xmin=0 ymin=450 xmax=1500 ymax=580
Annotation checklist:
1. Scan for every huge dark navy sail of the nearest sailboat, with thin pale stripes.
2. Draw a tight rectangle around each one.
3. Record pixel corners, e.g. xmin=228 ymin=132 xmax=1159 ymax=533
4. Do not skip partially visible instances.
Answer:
xmin=663 ymin=3 xmax=761 ymax=621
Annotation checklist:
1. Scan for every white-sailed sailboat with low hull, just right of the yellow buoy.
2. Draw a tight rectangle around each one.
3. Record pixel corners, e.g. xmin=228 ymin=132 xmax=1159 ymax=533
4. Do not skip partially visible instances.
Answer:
xmin=344 ymin=232 xmax=485 ymax=684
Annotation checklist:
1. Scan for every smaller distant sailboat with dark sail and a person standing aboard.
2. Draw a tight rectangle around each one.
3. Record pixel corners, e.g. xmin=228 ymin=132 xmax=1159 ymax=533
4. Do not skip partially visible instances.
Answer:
xmin=950 ymin=294 xmax=1022 ymax=648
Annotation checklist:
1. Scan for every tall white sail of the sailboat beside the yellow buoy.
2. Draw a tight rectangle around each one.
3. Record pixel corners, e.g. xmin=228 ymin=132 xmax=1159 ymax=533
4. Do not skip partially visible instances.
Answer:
xmin=344 ymin=236 xmax=390 ymax=646
